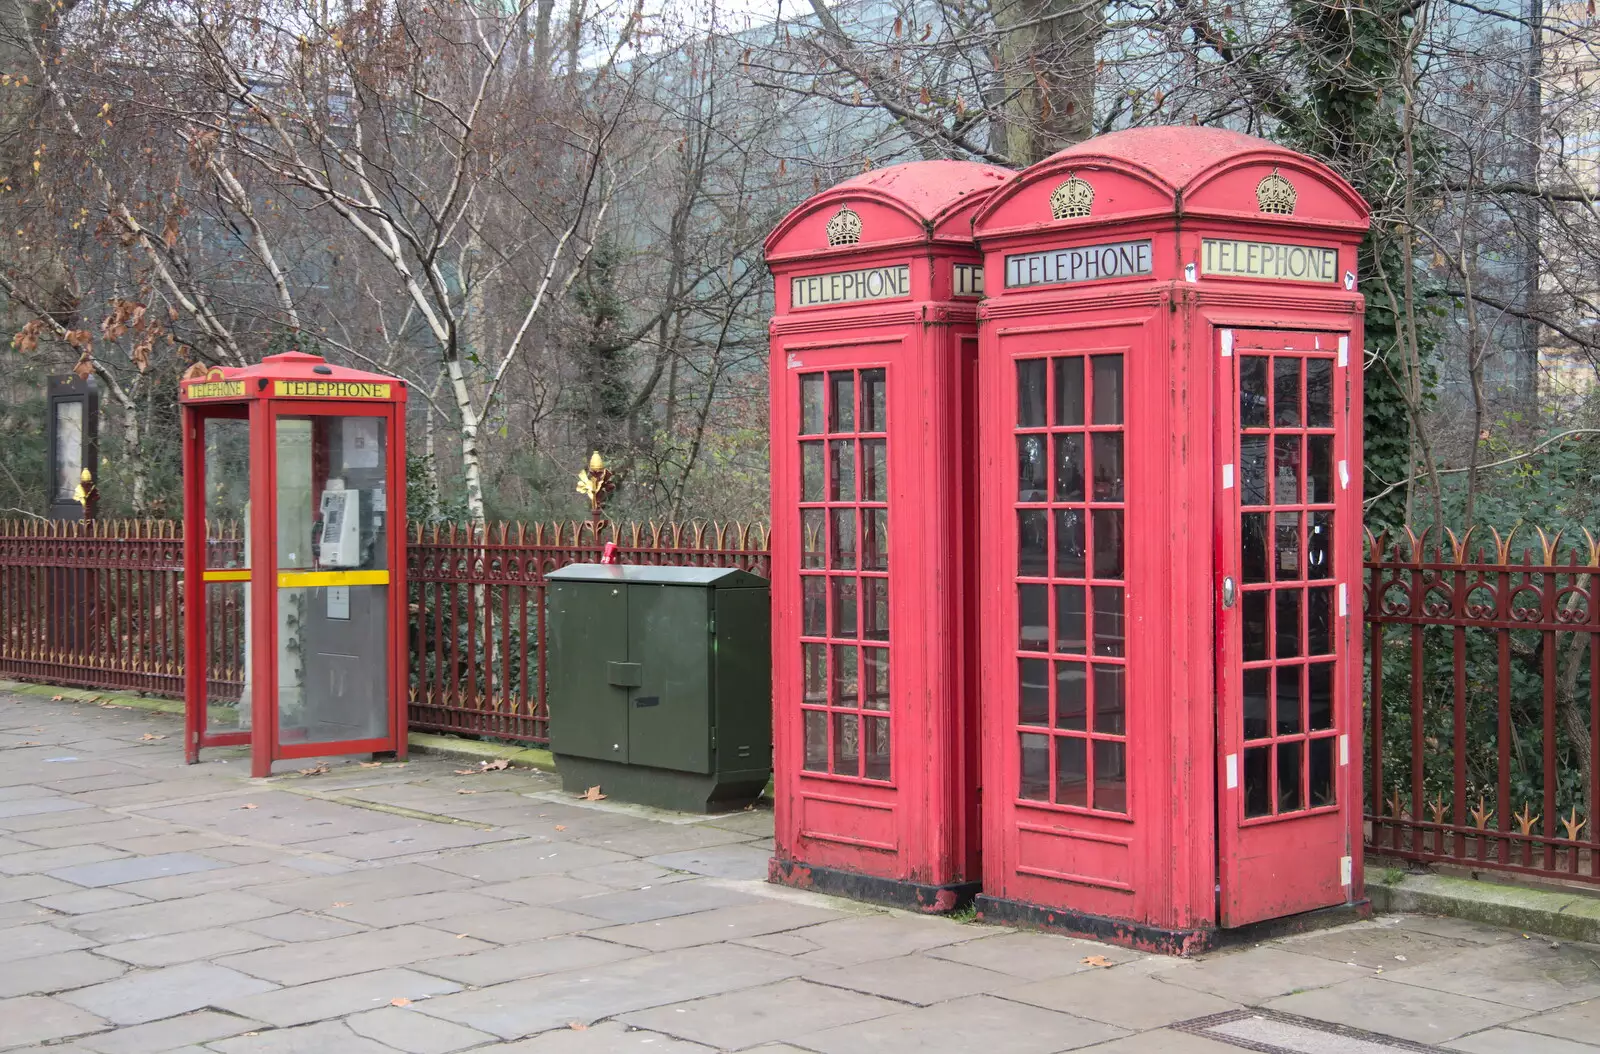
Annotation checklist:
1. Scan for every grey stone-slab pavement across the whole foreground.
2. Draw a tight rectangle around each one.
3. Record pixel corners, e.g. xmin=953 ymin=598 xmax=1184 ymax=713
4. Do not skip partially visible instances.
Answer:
xmin=0 ymin=694 xmax=1600 ymax=1054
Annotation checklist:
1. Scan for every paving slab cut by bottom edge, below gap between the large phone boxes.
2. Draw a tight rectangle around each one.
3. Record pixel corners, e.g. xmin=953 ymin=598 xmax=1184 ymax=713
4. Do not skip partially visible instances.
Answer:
xmin=792 ymin=995 xmax=1125 ymax=1054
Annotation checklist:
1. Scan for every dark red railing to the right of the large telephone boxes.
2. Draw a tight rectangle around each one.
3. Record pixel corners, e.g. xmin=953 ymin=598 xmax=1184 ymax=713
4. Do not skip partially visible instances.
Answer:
xmin=1365 ymin=531 xmax=1600 ymax=883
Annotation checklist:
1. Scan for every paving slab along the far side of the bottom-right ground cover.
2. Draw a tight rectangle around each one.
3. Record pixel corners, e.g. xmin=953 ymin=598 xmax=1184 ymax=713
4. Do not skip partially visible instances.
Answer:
xmin=1266 ymin=977 xmax=1523 ymax=1044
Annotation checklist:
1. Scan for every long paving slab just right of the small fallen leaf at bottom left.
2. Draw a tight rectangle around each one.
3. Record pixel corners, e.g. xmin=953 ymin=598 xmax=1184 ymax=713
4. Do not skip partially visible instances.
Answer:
xmin=418 ymin=945 xmax=797 ymax=1040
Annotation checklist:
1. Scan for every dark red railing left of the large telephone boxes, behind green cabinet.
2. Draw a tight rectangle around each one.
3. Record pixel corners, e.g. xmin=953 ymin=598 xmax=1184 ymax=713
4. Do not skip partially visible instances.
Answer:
xmin=0 ymin=520 xmax=768 ymax=742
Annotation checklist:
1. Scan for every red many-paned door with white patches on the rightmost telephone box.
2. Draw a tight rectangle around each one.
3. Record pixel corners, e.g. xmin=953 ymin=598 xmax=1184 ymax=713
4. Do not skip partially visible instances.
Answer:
xmin=1214 ymin=329 xmax=1360 ymax=926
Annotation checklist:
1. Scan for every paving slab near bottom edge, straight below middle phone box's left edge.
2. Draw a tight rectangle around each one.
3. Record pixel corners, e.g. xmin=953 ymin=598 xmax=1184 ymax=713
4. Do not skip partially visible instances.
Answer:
xmin=621 ymin=979 xmax=906 ymax=1051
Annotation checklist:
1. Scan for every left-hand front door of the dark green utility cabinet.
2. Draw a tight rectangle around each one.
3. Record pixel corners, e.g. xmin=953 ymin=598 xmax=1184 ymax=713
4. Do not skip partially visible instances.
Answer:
xmin=547 ymin=582 xmax=630 ymax=763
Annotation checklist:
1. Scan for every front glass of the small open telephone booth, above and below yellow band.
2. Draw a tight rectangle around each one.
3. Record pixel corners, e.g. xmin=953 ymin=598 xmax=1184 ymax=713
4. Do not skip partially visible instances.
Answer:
xmin=275 ymin=416 xmax=389 ymax=742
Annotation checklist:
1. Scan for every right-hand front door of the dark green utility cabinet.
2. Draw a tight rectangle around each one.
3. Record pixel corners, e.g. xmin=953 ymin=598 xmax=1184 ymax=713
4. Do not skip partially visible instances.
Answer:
xmin=627 ymin=585 xmax=710 ymax=773
